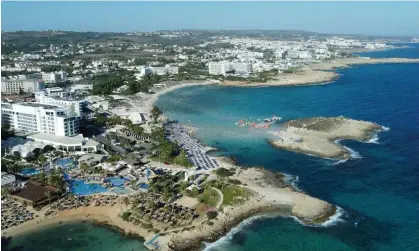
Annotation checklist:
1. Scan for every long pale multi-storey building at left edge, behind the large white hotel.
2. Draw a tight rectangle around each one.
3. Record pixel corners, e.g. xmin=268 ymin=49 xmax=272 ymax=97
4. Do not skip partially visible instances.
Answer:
xmin=1 ymin=79 xmax=45 ymax=94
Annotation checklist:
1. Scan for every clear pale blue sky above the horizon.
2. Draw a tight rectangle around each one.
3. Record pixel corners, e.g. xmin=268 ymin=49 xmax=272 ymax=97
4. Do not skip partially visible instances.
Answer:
xmin=1 ymin=1 xmax=419 ymax=36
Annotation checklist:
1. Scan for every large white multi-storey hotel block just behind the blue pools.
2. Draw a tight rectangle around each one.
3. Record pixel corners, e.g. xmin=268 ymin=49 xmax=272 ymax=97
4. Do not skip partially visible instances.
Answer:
xmin=1 ymin=103 xmax=79 ymax=137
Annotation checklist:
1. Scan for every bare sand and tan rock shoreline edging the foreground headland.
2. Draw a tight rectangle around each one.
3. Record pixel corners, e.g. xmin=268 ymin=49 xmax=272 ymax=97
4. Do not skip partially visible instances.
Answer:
xmin=2 ymin=166 xmax=335 ymax=250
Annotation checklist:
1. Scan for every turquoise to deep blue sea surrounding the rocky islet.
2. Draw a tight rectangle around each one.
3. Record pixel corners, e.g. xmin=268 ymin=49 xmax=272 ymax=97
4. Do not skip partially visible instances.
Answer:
xmin=6 ymin=44 xmax=419 ymax=251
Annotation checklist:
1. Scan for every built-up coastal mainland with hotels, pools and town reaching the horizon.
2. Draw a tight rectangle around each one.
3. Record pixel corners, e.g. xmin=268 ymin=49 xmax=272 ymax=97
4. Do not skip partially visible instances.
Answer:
xmin=1 ymin=31 xmax=418 ymax=249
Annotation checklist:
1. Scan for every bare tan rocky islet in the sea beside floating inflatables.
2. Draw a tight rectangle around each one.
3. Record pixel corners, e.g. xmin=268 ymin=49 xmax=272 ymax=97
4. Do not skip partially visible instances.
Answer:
xmin=269 ymin=117 xmax=383 ymax=159
